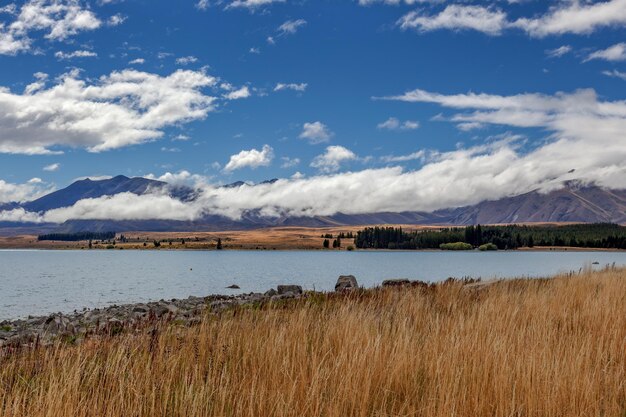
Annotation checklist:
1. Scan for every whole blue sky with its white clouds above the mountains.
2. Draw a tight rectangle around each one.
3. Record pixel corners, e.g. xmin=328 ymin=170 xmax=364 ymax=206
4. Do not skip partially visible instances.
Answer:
xmin=0 ymin=0 xmax=626 ymax=222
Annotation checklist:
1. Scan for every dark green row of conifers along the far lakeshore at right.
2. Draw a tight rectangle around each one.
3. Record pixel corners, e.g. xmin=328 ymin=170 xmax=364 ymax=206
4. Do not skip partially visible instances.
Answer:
xmin=354 ymin=223 xmax=626 ymax=250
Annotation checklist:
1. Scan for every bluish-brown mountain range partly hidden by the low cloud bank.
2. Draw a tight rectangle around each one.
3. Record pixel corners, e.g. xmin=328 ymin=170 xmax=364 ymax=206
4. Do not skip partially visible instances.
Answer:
xmin=0 ymin=175 xmax=626 ymax=234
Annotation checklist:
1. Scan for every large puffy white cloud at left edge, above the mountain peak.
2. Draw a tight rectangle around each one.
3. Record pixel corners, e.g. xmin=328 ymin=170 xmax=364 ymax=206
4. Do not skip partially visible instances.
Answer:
xmin=0 ymin=69 xmax=216 ymax=154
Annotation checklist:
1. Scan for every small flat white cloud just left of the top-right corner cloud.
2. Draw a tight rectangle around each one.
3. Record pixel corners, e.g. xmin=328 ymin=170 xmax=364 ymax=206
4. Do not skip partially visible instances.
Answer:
xmin=398 ymin=4 xmax=507 ymax=35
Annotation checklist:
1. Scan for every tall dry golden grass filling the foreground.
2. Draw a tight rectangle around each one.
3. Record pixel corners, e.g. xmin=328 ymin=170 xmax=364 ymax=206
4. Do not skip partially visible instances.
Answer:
xmin=0 ymin=270 xmax=626 ymax=417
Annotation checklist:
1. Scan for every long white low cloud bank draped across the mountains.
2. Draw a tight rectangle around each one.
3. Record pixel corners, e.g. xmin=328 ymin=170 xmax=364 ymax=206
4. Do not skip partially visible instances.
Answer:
xmin=0 ymin=86 xmax=626 ymax=223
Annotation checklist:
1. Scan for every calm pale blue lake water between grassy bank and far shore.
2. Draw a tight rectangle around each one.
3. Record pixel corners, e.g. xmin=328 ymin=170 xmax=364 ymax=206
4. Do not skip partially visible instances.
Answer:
xmin=0 ymin=250 xmax=626 ymax=320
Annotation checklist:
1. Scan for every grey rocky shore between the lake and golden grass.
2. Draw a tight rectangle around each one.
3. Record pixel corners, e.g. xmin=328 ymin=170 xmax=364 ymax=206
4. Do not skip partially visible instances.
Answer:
xmin=0 ymin=275 xmax=475 ymax=350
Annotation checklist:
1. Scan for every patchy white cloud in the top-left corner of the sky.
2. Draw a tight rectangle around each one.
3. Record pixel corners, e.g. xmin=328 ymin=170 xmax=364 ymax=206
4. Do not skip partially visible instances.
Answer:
xmin=0 ymin=0 xmax=102 ymax=55
